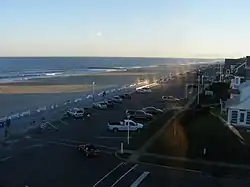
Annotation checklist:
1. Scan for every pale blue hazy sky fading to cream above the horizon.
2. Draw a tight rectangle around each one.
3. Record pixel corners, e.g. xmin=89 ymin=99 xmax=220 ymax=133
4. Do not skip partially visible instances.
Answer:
xmin=0 ymin=0 xmax=250 ymax=57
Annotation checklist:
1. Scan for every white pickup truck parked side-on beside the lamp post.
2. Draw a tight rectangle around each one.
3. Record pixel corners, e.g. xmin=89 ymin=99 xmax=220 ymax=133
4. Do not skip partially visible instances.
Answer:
xmin=108 ymin=119 xmax=143 ymax=132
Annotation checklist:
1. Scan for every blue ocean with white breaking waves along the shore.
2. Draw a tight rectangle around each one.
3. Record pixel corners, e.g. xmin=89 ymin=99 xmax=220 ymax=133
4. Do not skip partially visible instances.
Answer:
xmin=0 ymin=57 xmax=211 ymax=83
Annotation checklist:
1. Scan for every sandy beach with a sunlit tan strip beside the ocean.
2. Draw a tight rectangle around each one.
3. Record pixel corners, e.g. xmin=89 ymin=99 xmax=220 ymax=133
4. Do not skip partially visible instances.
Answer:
xmin=0 ymin=68 xmax=188 ymax=117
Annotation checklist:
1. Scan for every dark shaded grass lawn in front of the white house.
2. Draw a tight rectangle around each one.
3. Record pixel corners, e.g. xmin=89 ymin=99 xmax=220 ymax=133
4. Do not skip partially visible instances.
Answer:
xmin=148 ymin=111 xmax=250 ymax=163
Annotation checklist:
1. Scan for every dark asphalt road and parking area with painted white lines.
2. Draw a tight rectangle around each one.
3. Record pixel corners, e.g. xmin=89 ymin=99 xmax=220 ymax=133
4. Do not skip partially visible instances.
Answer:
xmin=0 ymin=72 xmax=249 ymax=187
